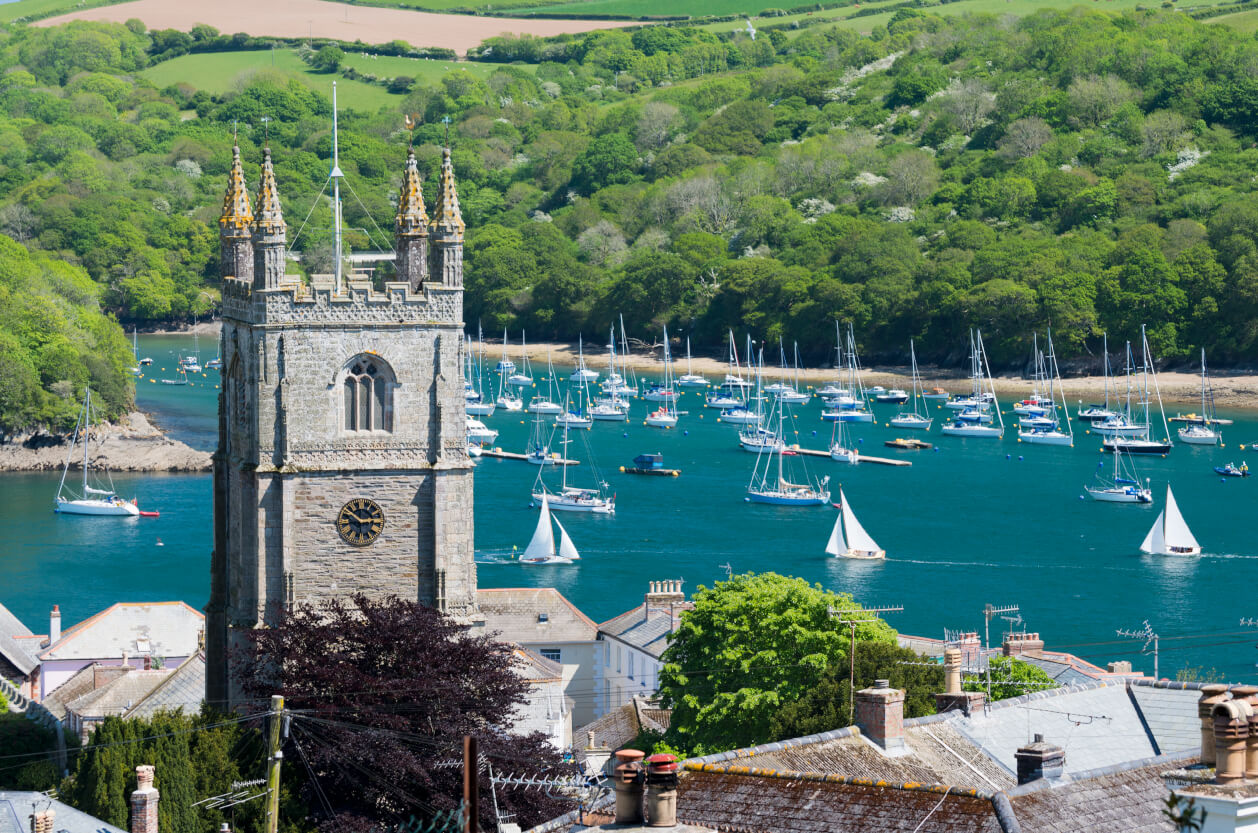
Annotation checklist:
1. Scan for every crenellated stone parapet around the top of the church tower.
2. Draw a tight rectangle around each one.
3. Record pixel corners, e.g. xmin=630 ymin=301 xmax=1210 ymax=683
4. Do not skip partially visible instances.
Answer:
xmin=223 ymin=276 xmax=463 ymax=327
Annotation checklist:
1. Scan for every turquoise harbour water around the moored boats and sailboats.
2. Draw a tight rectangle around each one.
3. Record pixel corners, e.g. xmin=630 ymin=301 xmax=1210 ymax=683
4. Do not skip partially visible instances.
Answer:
xmin=0 ymin=336 xmax=1258 ymax=679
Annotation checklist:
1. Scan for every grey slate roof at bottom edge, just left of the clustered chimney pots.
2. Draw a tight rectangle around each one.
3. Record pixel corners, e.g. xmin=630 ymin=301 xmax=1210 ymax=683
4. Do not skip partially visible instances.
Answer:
xmin=1009 ymin=755 xmax=1195 ymax=833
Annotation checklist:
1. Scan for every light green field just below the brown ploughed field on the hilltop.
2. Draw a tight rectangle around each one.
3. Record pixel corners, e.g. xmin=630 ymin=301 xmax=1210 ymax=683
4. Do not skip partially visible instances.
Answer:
xmin=140 ymin=49 xmax=515 ymax=112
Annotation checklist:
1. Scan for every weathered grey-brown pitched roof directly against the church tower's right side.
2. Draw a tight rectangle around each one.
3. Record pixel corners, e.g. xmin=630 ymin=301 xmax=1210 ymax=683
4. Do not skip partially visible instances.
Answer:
xmin=476 ymin=588 xmax=599 ymax=646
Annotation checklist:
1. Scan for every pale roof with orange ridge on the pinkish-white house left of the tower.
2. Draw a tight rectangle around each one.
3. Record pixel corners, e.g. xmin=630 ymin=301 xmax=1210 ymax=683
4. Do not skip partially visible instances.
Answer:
xmin=39 ymin=601 xmax=205 ymax=661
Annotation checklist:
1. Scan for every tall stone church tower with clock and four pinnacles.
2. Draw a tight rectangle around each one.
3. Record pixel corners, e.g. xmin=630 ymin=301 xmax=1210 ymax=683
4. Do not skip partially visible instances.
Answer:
xmin=206 ymin=138 xmax=479 ymax=707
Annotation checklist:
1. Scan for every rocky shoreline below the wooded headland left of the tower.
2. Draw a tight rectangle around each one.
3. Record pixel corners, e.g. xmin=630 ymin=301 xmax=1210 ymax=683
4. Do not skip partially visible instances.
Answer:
xmin=0 ymin=410 xmax=211 ymax=473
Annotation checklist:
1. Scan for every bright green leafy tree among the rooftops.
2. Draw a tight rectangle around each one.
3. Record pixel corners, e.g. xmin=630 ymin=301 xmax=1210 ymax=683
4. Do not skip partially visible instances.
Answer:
xmin=659 ymin=573 xmax=896 ymax=754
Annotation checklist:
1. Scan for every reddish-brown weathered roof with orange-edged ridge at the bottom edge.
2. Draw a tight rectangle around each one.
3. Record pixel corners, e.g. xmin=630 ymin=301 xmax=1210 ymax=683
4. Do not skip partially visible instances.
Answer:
xmin=677 ymin=764 xmax=1003 ymax=833
